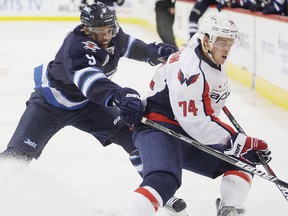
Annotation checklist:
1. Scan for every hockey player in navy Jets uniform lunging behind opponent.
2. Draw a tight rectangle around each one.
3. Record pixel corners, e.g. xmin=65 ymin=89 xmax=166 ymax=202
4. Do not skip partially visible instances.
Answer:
xmin=0 ymin=3 xmax=185 ymax=214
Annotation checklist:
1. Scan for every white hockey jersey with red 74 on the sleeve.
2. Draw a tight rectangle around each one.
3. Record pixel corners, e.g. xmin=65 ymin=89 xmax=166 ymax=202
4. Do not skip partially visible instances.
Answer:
xmin=145 ymin=38 xmax=236 ymax=145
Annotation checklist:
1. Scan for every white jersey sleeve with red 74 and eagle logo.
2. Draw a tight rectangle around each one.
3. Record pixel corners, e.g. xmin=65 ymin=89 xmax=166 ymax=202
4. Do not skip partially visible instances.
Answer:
xmin=166 ymin=50 xmax=235 ymax=145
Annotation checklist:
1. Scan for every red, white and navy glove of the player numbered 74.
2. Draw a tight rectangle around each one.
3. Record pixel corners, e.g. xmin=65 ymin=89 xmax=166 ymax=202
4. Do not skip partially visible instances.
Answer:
xmin=224 ymin=133 xmax=272 ymax=165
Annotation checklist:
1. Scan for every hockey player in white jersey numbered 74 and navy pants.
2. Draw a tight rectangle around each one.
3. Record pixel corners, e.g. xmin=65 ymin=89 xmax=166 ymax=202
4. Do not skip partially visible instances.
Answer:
xmin=123 ymin=12 xmax=271 ymax=216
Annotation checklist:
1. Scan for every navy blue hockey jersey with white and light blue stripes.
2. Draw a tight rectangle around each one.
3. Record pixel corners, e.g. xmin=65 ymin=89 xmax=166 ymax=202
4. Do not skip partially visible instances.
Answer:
xmin=34 ymin=25 xmax=148 ymax=110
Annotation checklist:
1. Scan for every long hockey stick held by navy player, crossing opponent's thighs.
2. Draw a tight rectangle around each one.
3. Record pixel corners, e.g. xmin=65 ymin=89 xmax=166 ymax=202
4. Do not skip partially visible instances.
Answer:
xmin=141 ymin=117 xmax=288 ymax=191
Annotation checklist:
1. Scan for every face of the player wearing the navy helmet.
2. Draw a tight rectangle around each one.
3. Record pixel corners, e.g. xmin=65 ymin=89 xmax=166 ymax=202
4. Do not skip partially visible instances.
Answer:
xmin=90 ymin=26 xmax=115 ymax=49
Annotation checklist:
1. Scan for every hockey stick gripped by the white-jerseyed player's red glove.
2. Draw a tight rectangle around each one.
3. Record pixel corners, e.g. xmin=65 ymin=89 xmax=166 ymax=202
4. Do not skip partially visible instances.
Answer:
xmin=222 ymin=106 xmax=288 ymax=201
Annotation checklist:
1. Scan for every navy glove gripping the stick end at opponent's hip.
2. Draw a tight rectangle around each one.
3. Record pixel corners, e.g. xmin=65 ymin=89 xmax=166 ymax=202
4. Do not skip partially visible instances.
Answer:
xmin=113 ymin=88 xmax=144 ymax=127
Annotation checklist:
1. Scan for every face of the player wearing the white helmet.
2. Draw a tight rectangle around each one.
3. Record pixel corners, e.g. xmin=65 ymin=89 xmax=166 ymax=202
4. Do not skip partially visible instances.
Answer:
xmin=211 ymin=37 xmax=234 ymax=65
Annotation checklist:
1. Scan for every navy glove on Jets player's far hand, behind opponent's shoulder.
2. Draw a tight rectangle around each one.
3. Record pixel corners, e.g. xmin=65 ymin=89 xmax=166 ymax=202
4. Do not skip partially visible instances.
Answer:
xmin=147 ymin=42 xmax=178 ymax=66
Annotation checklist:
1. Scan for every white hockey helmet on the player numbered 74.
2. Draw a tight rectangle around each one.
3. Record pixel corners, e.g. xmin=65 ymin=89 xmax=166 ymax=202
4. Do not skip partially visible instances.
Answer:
xmin=200 ymin=12 xmax=239 ymax=44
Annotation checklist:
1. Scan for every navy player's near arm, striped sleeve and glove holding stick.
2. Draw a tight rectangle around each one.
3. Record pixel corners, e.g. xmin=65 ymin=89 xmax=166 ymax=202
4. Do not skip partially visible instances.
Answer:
xmin=67 ymin=46 xmax=143 ymax=126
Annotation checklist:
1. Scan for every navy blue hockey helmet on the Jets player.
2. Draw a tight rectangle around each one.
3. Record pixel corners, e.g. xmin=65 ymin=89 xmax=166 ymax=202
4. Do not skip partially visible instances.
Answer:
xmin=80 ymin=2 xmax=117 ymax=27
